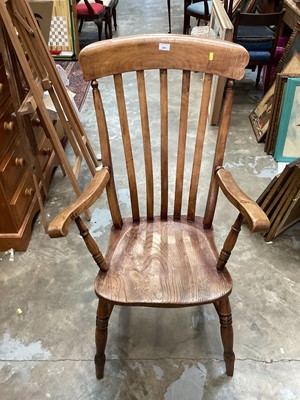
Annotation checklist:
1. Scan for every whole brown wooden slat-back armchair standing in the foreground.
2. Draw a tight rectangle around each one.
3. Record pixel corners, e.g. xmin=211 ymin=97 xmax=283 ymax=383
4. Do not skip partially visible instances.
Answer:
xmin=49 ymin=34 xmax=269 ymax=379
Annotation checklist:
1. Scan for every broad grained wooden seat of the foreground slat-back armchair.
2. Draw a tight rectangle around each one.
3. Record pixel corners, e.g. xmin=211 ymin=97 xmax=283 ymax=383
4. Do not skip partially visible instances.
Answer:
xmin=95 ymin=218 xmax=232 ymax=307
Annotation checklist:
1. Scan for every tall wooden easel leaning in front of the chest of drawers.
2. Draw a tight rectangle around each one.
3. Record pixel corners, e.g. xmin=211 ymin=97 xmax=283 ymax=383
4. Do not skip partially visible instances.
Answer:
xmin=0 ymin=0 xmax=98 ymax=222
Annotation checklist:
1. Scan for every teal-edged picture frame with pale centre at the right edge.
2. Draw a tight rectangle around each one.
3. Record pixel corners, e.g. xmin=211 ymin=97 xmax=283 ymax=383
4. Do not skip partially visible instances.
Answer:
xmin=274 ymin=78 xmax=300 ymax=162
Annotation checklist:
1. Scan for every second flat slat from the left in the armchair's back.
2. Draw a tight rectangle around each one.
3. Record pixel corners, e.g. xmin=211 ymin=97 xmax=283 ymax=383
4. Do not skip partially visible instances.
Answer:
xmin=137 ymin=71 xmax=154 ymax=221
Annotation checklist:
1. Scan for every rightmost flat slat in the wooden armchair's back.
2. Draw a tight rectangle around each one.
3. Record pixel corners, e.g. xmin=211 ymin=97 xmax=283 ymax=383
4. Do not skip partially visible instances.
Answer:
xmin=187 ymin=74 xmax=213 ymax=221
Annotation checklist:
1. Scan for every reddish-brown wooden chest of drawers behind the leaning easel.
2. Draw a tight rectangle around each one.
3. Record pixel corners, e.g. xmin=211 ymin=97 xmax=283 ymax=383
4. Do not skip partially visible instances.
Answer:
xmin=0 ymin=50 xmax=58 ymax=251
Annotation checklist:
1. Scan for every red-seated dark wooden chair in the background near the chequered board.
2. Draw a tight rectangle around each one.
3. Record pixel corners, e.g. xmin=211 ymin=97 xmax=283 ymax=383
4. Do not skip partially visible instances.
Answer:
xmin=76 ymin=0 xmax=105 ymax=40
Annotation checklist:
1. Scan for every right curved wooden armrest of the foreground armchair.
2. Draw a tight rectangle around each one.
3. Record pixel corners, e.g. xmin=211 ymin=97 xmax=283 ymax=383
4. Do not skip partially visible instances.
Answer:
xmin=216 ymin=167 xmax=270 ymax=232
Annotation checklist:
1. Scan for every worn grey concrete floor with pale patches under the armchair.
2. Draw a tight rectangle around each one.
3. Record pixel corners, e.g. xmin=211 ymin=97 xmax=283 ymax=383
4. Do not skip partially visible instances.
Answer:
xmin=0 ymin=0 xmax=300 ymax=400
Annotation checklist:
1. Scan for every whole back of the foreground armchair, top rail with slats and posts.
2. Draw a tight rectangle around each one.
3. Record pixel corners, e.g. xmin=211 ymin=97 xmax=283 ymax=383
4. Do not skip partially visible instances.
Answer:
xmin=80 ymin=35 xmax=247 ymax=226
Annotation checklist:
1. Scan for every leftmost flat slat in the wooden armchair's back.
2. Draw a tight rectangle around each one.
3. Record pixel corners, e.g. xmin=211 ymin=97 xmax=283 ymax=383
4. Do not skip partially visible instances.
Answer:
xmin=114 ymin=74 xmax=140 ymax=222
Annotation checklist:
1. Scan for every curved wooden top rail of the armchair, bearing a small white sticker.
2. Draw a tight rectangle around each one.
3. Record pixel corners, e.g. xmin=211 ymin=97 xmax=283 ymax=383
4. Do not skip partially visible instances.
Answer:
xmin=79 ymin=34 xmax=249 ymax=81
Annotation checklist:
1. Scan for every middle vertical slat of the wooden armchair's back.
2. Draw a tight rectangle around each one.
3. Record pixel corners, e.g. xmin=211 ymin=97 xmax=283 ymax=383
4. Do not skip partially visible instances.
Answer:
xmin=160 ymin=69 xmax=169 ymax=219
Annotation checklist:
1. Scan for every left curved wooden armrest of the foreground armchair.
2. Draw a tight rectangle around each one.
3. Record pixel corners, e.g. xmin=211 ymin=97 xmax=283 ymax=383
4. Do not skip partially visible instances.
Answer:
xmin=48 ymin=167 xmax=110 ymax=238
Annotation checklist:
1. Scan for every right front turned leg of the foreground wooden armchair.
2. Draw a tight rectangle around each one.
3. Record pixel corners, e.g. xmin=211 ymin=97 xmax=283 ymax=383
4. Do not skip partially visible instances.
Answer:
xmin=214 ymin=297 xmax=235 ymax=376
